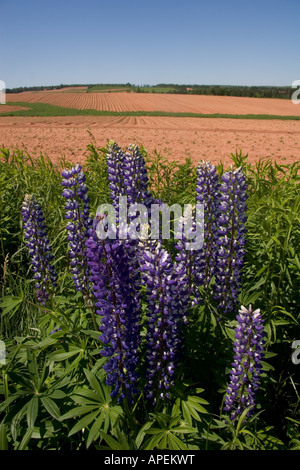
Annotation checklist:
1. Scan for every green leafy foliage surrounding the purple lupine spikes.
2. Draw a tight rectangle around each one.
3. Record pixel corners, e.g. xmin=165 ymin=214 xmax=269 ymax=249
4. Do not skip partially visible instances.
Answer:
xmin=0 ymin=144 xmax=300 ymax=451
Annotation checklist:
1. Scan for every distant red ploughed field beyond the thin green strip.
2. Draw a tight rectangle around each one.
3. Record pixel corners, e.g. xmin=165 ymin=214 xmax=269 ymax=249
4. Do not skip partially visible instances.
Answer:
xmin=7 ymin=91 xmax=300 ymax=116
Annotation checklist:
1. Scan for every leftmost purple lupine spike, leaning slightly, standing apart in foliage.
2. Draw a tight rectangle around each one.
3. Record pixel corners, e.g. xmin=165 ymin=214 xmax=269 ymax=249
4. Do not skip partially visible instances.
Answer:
xmin=22 ymin=194 xmax=57 ymax=306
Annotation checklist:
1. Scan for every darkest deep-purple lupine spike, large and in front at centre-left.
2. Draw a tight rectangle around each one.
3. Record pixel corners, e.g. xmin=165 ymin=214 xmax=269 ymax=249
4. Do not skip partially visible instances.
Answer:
xmin=86 ymin=214 xmax=141 ymax=401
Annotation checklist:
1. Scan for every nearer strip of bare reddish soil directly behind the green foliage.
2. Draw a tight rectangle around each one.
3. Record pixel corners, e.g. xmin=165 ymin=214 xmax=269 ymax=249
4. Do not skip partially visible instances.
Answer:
xmin=0 ymin=116 xmax=300 ymax=168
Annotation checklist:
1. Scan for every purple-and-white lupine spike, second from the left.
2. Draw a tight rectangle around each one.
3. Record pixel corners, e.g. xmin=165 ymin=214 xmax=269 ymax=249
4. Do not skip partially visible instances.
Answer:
xmin=61 ymin=164 xmax=92 ymax=293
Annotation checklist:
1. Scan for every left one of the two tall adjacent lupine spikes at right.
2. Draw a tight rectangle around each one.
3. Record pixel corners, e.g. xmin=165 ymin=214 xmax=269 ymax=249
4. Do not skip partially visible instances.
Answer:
xmin=194 ymin=161 xmax=220 ymax=293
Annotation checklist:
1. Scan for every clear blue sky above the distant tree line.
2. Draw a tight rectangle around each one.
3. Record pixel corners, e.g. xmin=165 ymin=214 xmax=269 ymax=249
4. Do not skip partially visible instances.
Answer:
xmin=0 ymin=0 xmax=300 ymax=88
